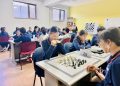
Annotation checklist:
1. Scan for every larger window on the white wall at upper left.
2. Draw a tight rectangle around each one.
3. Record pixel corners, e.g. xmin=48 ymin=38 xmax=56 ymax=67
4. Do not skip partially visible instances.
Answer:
xmin=13 ymin=1 xmax=36 ymax=19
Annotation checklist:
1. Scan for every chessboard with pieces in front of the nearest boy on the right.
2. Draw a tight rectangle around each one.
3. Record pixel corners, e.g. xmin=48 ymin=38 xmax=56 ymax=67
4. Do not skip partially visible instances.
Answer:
xmin=47 ymin=53 xmax=100 ymax=77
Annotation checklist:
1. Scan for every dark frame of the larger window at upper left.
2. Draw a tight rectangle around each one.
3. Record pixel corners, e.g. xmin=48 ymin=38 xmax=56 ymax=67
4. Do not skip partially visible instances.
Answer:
xmin=13 ymin=1 xmax=37 ymax=19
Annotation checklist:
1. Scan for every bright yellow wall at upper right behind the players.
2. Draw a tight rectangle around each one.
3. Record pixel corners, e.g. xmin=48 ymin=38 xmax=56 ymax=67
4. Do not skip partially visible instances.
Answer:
xmin=70 ymin=0 xmax=120 ymax=30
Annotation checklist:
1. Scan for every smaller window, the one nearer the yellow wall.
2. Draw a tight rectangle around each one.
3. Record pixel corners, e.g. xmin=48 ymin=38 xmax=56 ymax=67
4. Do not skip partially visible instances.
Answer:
xmin=53 ymin=8 xmax=65 ymax=21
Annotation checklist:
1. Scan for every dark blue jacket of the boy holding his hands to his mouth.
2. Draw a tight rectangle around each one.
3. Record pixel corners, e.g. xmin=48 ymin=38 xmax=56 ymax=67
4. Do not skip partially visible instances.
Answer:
xmin=42 ymin=38 xmax=66 ymax=59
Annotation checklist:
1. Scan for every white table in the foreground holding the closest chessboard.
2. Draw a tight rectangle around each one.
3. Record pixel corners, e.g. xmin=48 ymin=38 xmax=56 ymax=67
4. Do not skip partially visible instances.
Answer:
xmin=36 ymin=51 xmax=110 ymax=86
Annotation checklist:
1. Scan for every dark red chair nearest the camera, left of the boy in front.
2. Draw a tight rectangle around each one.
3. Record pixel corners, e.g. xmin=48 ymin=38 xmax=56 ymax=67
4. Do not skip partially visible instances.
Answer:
xmin=19 ymin=42 xmax=36 ymax=70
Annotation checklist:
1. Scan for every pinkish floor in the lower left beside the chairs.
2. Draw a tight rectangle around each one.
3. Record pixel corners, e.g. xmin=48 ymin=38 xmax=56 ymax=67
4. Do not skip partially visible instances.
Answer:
xmin=0 ymin=52 xmax=44 ymax=86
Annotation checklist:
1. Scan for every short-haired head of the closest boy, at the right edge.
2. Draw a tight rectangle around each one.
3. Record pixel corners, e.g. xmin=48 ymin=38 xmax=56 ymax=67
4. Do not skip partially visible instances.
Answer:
xmin=99 ymin=27 xmax=120 ymax=53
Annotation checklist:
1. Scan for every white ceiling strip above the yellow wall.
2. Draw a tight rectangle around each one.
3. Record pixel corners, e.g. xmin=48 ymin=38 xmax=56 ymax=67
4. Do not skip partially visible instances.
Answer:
xmin=40 ymin=0 xmax=98 ymax=6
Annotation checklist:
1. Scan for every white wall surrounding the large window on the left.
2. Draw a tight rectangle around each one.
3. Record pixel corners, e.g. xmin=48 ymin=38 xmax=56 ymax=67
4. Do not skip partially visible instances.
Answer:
xmin=0 ymin=0 xmax=68 ymax=34
